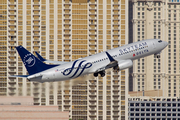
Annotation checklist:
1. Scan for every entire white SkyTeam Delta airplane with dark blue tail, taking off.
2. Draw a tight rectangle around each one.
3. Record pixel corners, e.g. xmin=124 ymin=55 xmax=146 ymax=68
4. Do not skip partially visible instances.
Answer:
xmin=10 ymin=39 xmax=168 ymax=83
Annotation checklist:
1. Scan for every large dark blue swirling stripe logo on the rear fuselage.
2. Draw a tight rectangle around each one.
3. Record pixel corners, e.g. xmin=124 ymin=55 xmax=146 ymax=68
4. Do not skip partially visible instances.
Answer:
xmin=62 ymin=60 xmax=92 ymax=78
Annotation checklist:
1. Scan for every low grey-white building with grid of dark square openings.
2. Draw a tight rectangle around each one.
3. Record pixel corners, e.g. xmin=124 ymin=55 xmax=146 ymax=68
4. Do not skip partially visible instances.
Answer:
xmin=128 ymin=97 xmax=180 ymax=120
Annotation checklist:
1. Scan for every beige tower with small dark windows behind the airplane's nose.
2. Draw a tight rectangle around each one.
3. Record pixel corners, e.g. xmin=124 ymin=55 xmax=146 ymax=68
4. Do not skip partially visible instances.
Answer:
xmin=129 ymin=0 xmax=180 ymax=97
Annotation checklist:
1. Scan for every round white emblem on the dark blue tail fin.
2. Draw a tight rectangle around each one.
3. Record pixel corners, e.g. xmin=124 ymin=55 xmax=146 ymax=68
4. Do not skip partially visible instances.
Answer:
xmin=23 ymin=53 xmax=36 ymax=67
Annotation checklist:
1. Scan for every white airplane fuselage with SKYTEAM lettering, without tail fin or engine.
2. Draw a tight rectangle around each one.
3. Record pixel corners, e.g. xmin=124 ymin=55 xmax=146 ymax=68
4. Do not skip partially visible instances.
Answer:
xmin=28 ymin=39 xmax=167 ymax=82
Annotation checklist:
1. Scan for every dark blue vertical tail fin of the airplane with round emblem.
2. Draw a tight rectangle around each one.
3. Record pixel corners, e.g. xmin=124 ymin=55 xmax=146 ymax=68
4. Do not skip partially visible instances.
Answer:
xmin=16 ymin=46 xmax=57 ymax=75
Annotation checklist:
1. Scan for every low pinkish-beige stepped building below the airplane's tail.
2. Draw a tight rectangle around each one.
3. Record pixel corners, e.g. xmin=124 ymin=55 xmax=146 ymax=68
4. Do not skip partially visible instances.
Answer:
xmin=0 ymin=96 xmax=69 ymax=120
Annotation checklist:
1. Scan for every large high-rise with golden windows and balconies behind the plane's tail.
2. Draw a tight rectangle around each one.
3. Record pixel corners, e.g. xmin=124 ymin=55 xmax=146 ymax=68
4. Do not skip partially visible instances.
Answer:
xmin=0 ymin=0 xmax=129 ymax=120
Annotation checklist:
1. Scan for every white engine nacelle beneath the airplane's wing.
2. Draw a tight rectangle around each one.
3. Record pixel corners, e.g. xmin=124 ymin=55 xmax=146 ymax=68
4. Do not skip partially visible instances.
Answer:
xmin=118 ymin=60 xmax=133 ymax=70
